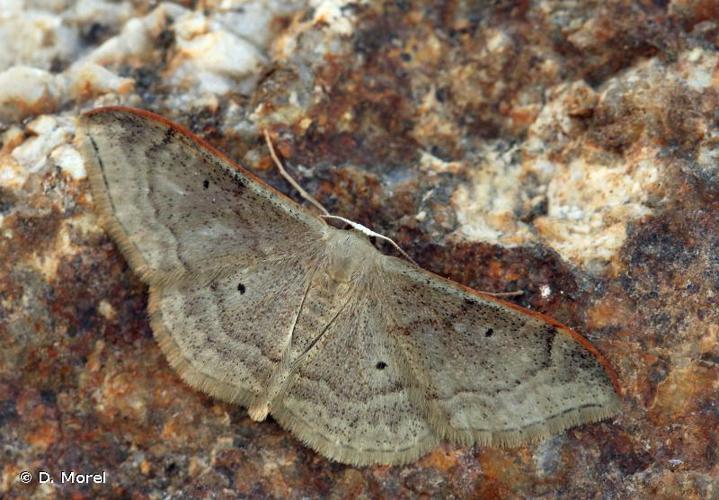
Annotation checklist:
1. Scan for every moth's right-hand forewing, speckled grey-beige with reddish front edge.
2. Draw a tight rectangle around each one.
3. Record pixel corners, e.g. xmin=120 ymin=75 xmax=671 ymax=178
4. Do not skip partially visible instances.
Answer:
xmin=381 ymin=257 xmax=619 ymax=446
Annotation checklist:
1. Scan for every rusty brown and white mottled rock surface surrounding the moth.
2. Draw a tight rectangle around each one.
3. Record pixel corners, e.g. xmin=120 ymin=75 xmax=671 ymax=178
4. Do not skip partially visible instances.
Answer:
xmin=0 ymin=0 xmax=719 ymax=498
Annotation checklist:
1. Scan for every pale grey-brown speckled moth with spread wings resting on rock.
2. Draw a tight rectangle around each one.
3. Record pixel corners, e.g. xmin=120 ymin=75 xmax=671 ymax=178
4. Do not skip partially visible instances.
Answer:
xmin=79 ymin=107 xmax=620 ymax=465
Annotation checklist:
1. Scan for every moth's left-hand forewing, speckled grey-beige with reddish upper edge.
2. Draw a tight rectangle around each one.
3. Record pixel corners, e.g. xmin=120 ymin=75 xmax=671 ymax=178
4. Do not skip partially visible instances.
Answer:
xmin=79 ymin=107 xmax=325 ymax=284
